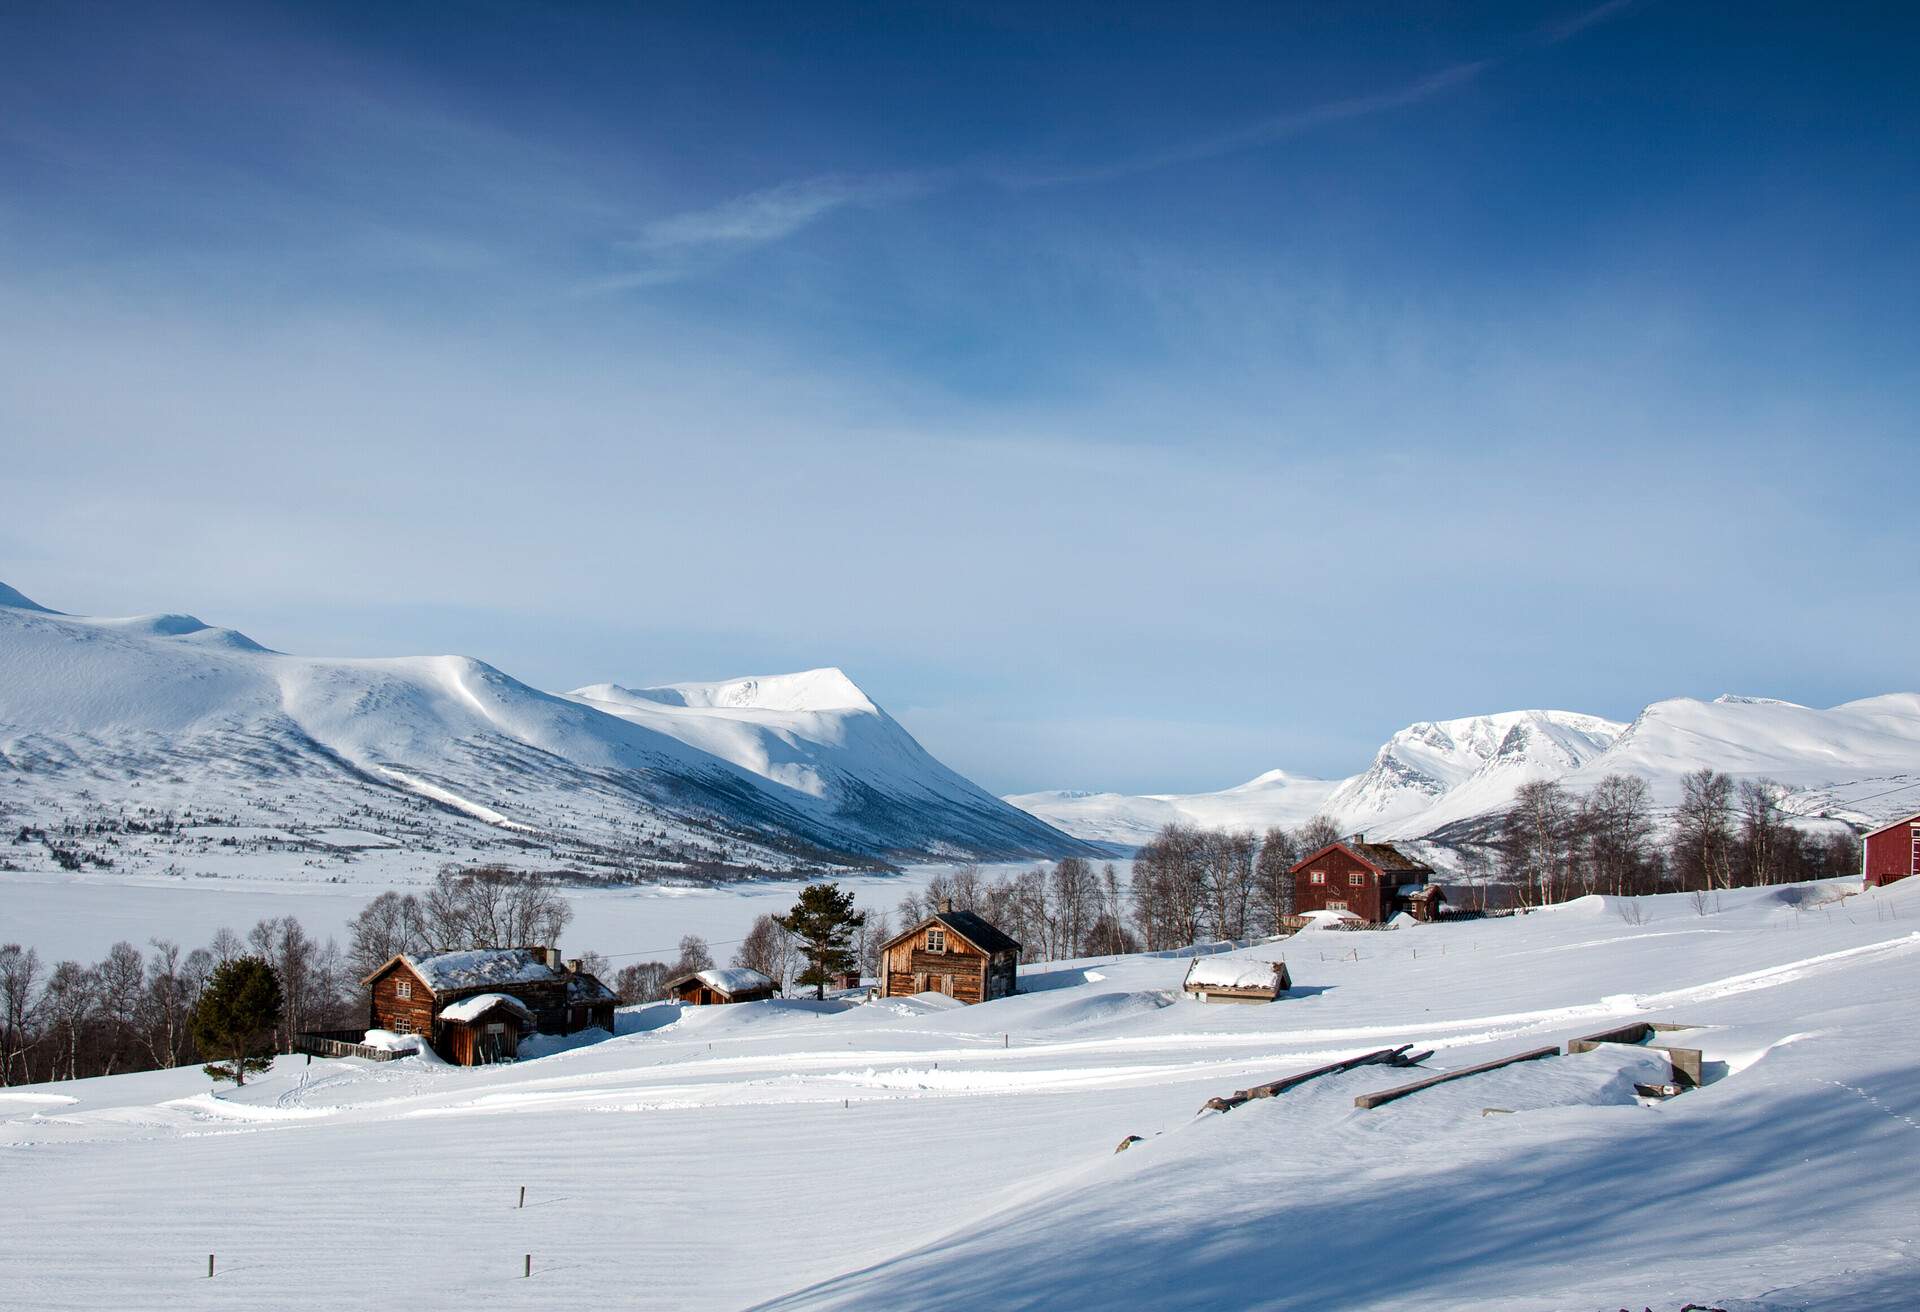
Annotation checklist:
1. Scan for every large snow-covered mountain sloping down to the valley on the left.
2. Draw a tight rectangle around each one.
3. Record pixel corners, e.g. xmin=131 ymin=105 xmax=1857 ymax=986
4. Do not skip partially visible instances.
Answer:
xmin=0 ymin=588 xmax=1081 ymax=868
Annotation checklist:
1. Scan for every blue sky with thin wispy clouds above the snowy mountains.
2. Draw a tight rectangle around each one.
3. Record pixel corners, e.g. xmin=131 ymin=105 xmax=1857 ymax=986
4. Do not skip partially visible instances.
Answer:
xmin=0 ymin=0 xmax=1920 ymax=791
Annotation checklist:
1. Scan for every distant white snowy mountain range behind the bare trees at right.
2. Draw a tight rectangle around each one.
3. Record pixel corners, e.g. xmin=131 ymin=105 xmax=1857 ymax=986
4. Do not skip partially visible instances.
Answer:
xmin=1006 ymin=693 xmax=1920 ymax=847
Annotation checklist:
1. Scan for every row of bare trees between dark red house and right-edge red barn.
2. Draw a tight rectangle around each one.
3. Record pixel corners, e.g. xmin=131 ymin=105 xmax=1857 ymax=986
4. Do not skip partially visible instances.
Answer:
xmin=1497 ymin=768 xmax=1860 ymax=905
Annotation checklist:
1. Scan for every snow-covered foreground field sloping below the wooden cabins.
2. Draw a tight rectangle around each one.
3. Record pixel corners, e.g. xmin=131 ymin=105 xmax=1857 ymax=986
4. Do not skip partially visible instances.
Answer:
xmin=0 ymin=880 xmax=1920 ymax=1312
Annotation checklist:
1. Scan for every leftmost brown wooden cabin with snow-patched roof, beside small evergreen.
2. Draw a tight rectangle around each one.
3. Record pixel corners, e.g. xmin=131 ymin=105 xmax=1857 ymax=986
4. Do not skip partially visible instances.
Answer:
xmin=361 ymin=947 xmax=618 ymax=1066
